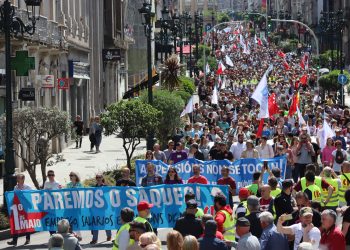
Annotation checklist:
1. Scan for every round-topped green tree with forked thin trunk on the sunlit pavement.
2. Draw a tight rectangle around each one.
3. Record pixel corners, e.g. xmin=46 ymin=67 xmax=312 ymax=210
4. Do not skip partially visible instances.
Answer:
xmin=101 ymin=99 xmax=162 ymax=169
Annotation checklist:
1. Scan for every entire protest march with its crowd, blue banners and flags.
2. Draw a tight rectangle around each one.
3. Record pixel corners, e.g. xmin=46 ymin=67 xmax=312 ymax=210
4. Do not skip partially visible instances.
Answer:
xmin=6 ymin=10 xmax=350 ymax=250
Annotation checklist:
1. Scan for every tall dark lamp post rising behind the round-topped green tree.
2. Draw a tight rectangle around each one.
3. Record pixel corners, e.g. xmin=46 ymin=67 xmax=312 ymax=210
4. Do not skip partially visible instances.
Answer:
xmin=139 ymin=2 xmax=155 ymax=150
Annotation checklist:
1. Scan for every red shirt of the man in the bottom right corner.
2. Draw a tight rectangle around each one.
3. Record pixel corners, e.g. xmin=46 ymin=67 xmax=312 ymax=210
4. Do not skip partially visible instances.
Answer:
xmin=320 ymin=227 xmax=345 ymax=250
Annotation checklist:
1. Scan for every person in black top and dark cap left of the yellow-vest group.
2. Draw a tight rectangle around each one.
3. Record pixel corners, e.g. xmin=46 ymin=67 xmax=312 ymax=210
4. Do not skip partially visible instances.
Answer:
xmin=274 ymin=180 xmax=294 ymax=221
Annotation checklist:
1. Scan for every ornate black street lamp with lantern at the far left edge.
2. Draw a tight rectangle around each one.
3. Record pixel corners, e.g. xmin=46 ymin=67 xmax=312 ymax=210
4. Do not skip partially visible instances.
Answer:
xmin=0 ymin=0 xmax=41 ymax=199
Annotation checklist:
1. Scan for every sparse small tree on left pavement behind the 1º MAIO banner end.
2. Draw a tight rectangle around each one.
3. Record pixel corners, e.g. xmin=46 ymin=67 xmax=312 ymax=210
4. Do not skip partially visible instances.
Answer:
xmin=9 ymin=107 xmax=71 ymax=189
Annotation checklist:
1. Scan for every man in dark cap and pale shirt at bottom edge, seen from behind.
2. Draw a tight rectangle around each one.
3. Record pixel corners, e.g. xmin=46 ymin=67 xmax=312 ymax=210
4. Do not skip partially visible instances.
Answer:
xmin=232 ymin=217 xmax=261 ymax=250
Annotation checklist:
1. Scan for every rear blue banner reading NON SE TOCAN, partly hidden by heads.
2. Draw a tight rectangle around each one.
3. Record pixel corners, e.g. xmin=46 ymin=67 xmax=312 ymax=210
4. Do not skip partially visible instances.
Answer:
xmin=135 ymin=156 xmax=287 ymax=190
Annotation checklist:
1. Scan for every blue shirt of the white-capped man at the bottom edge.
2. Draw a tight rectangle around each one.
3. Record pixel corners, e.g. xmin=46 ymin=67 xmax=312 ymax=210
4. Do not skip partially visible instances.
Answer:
xmin=260 ymin=224 xmax=289 ymax=250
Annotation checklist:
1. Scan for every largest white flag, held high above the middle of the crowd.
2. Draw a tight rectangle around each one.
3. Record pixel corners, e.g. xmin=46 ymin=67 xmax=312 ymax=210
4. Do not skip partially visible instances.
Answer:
xmin=252 ymin=73 xmax=269 ymax=119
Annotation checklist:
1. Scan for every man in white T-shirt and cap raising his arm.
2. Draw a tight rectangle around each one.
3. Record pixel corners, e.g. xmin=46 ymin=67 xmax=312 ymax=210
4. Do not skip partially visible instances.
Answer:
xmin=277 ymin=207 xmax=321 ymax=250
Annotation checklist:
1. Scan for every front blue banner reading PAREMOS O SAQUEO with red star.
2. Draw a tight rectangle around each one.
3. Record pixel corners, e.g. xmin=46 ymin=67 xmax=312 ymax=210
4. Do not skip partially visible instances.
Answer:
xmin=5 ymin=184 xmax=228 ymax=234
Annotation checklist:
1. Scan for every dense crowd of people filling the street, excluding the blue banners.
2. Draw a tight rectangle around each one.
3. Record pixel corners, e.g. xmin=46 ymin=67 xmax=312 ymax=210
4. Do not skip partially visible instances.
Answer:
xmin=9 ymin=23 xmax=350 ymax=250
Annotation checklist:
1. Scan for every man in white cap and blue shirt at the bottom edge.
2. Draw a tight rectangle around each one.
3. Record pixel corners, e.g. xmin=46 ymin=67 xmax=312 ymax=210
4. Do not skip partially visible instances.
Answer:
xmin=259 ymin=211 xmax=289 ymax=250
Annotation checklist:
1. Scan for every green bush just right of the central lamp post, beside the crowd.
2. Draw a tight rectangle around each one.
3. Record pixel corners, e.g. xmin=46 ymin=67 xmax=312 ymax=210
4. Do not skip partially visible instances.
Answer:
xmin=140 ymin=90 xmax=185 ymax=147
